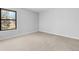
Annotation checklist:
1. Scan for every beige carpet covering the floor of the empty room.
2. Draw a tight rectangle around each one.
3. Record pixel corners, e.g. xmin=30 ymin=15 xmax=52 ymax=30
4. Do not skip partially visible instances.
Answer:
xmin=0 ymin=32 xmax=79 ymax=51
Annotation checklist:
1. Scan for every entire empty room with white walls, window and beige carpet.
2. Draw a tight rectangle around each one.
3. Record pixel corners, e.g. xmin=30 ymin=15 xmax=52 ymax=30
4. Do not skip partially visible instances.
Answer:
xmin=0 ymin=8 xmax=79 ymax=51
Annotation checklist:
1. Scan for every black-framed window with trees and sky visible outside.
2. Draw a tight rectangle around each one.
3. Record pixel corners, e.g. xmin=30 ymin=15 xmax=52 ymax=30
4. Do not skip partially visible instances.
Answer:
xmin=0 ymin=8 xmax=17 ymax=30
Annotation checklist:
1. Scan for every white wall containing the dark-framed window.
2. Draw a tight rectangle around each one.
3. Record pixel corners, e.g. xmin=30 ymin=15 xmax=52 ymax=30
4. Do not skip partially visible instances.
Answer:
xmin=0 ymin=8 xmax=38 ymax=40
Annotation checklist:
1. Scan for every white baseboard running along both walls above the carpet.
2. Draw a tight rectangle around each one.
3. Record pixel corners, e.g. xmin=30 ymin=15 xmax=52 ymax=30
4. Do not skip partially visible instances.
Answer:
xmin=0 ymin=31 xmax=79 ymax=40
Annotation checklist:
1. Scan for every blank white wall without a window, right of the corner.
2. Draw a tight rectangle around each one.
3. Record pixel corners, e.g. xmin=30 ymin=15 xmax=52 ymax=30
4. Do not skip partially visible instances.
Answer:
xmin=39 ymin=8 xmax=79 ymax=39
